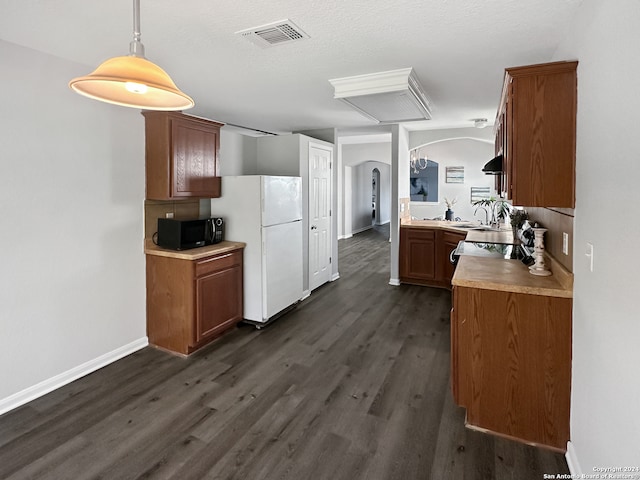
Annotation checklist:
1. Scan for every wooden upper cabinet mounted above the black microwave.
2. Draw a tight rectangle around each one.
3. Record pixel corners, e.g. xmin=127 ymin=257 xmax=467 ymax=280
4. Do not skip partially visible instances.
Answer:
xmin=142 ymin=111 xmax=223 ymax=200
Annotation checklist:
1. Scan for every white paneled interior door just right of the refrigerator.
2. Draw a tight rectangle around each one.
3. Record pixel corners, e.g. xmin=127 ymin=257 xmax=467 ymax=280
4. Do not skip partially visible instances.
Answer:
xmin=309 ymin=145 xmax=333 ymax=290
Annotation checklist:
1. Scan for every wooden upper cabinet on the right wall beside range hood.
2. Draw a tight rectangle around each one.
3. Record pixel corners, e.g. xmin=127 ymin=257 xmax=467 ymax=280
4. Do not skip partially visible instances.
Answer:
xmin=495 ymin=62 xmax=578 ymax=208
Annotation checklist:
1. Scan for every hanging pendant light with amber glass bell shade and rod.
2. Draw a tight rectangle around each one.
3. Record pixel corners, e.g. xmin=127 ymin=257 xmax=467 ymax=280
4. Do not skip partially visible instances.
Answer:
xmin=69 ymin=0 xmax=195 ymax=110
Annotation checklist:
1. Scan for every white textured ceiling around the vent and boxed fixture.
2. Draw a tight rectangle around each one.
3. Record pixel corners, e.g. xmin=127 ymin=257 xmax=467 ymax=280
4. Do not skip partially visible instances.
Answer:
xmin=0 ymin=0 xmax=582 ymax=132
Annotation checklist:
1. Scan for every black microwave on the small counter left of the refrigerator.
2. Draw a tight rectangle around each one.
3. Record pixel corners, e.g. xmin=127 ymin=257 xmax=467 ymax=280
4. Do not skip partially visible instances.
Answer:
xmin=157 ymin=217 xmax=224 ymax=250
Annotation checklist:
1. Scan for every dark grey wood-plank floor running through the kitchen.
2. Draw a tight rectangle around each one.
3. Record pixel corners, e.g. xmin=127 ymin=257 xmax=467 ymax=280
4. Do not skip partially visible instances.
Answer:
xmin=0 ymin=227 xmax=568 ymax=480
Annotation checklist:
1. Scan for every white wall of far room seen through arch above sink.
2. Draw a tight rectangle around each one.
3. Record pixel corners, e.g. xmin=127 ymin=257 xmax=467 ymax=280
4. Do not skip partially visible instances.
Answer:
xmin=410 ymin=138 xmax=496 ymax=222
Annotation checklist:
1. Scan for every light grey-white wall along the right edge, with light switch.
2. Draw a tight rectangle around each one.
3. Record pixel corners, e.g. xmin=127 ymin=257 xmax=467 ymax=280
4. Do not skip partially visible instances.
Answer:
xmin=554 ymin=0 xmax=640 ymax=474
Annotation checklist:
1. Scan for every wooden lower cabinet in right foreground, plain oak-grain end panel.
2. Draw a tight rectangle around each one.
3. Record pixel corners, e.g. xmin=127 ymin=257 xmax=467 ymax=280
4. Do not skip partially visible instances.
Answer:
xmin=451 ymin=286 xmax=572 ymax=451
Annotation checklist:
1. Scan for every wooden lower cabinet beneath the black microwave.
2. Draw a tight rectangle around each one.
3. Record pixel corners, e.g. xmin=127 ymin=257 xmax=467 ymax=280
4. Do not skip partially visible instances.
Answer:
xmin=147 ymin=249 xmax=243 ymax=355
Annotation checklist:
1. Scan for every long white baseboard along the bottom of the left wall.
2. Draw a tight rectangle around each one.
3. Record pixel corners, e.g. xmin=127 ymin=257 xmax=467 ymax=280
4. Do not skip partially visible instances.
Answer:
xmin=0 ymin=337 xmax=149 ymax=415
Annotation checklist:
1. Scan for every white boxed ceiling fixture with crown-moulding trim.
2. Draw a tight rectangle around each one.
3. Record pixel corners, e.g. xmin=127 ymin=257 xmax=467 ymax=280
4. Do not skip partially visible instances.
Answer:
xmin=329 ymin=68 xmax=431 ymax=123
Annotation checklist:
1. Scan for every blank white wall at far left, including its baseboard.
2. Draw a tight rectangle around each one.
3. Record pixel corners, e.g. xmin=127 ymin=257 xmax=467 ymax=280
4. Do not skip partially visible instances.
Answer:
xmin=0 ymin=41 xmax=147 ymax=412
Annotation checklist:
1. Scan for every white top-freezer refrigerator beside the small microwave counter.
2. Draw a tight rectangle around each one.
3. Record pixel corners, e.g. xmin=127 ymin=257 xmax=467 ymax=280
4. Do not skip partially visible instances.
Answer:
xmin=211 ymin=175 xmax=303 ymax=327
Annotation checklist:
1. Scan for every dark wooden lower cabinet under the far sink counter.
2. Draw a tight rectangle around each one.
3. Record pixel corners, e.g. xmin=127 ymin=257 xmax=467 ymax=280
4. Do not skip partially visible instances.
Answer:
xmin=400 ymin=227 xmax=466 ymax=288
